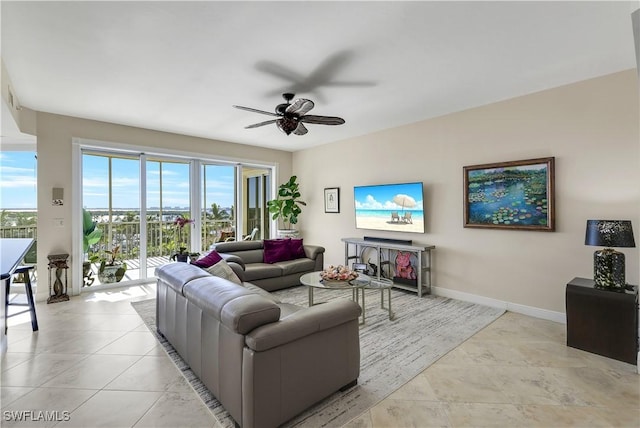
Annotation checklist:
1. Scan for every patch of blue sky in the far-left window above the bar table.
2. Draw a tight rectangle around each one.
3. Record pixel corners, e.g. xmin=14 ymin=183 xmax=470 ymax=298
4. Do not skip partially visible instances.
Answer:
xmin=0 ymin=152 xmax=37 ymax=209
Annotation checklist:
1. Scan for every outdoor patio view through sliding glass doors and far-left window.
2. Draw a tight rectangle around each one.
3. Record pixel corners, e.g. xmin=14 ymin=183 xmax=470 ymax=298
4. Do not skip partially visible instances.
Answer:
xmin=0 ymin=152 xmax=270 ymax=288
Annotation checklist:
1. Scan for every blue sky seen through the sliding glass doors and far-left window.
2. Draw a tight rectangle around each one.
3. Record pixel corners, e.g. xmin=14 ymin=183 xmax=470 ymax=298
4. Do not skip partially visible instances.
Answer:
xmin=0 ymin=152 xmax=234 ymax=209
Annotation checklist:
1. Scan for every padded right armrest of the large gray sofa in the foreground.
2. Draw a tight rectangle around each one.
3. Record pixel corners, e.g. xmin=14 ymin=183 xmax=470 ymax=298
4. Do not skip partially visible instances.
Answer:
xmin=245 ymin=299 xmax=362 ymax=352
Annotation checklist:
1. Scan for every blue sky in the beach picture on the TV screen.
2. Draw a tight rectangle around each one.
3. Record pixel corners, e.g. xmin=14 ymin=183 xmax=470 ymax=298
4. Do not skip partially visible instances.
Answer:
xmin=353 ymin=183 xmax=423 ymax=210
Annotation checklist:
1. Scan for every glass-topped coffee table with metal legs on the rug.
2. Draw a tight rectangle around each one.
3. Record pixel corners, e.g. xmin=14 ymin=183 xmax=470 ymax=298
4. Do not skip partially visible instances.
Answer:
xmin=300 ymin=271 xmax=394 ymax=324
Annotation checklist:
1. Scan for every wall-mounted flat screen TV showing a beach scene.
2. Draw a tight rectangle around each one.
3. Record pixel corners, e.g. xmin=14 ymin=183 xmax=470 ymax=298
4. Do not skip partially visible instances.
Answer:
xmin=353 ymin=183 xmax=424 ymax=233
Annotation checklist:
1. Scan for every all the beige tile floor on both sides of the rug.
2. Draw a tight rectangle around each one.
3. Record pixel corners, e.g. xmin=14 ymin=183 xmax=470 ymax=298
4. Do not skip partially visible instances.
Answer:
xmin=0 ymin=285 xmax=640 ymax=428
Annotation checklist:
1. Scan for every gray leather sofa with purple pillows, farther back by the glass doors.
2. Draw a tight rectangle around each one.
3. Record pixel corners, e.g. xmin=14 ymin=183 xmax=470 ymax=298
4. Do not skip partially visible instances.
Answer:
xmin=213 ymin=241 xmax=324 ymax=291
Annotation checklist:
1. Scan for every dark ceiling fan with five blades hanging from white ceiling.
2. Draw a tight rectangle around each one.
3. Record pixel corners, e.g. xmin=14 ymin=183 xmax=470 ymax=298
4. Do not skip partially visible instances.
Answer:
xmin=234 ymin=93 xmax=344 ymax=135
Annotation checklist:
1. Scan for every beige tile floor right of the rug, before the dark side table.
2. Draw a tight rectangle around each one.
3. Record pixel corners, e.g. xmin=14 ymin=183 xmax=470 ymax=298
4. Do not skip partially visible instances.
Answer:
xmin=347 ymin=312 xmax=640 ymax=428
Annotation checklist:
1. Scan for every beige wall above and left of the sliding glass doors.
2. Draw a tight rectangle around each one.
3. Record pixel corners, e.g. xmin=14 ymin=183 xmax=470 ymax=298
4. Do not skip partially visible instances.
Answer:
xmin=36 ymin=112 xmax=292 ymax=300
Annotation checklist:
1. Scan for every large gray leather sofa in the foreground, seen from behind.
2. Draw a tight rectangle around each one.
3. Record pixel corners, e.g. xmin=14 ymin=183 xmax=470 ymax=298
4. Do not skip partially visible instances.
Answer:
xmin=156 ymin=261 xmax=361 ymax=428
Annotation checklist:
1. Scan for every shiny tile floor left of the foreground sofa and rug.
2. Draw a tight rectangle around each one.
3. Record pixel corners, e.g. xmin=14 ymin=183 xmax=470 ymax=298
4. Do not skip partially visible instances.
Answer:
xmin=0 ymin=285 xmax=218 ymax=428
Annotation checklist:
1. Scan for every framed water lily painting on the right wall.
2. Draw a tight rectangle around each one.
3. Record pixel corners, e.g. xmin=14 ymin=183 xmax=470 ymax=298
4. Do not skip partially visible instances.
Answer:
xmin=463 ymin=157 xmax=555 ymax=232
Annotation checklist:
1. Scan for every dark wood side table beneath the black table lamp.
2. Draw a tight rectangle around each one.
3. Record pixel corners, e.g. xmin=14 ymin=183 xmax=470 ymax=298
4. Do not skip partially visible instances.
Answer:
xmin=566 ymin=278 xmax=638 ymax=365
